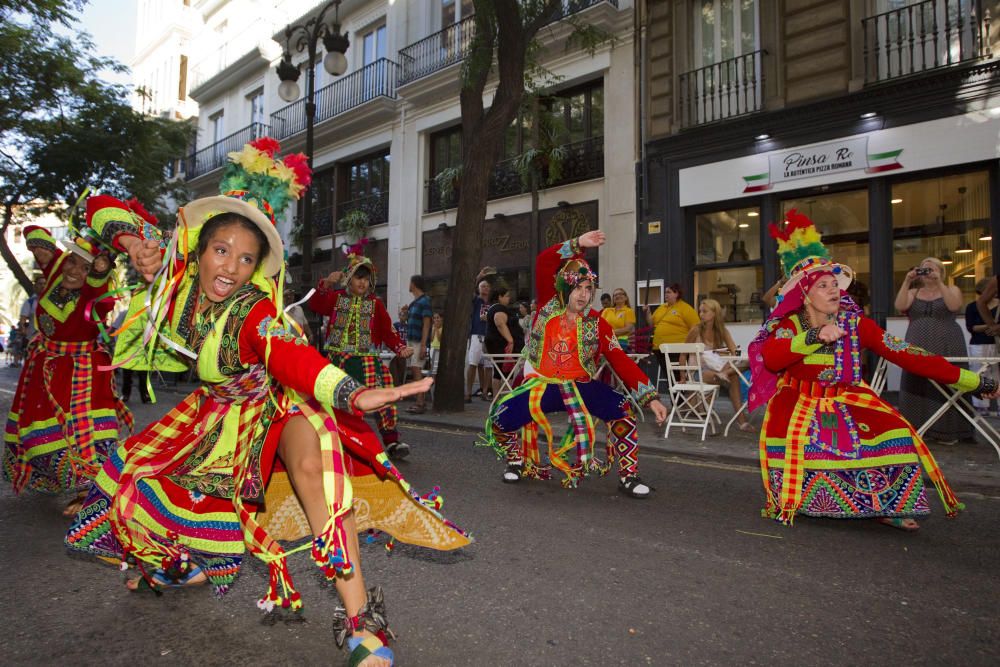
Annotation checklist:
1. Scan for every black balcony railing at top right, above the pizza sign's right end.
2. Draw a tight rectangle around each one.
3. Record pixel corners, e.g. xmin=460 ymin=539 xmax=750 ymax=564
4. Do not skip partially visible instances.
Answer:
xmin=861 ymin=0 xmax=989 ymax=83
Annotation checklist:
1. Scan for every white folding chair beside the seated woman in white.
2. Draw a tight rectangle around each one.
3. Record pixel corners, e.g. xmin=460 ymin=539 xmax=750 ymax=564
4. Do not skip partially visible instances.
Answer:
xmin=660 ymin=343 xmax=722 ymax=441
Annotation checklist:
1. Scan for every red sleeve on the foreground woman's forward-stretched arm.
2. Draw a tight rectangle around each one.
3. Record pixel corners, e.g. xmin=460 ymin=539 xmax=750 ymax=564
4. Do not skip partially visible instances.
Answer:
xmin=240 ymin=299 xmax=330 ymax=396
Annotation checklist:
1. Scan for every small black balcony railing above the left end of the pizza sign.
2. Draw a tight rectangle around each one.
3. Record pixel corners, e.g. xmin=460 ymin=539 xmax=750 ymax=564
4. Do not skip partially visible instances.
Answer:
xmin=680 ymin=51 xmax=765 ymax=127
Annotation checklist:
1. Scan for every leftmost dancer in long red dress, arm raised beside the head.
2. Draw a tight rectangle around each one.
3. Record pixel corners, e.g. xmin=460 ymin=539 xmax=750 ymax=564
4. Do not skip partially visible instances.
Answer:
xmin=3 ymin=227 xmax=132 ymax=516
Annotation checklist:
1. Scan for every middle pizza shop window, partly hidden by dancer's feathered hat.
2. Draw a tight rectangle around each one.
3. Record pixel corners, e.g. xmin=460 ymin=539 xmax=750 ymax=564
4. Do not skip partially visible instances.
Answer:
xmin=781 ymin=190 xmax=871 ymax=312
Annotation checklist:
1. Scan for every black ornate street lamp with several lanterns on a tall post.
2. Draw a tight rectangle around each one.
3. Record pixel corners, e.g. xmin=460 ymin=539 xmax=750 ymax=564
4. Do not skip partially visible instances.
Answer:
xmin=276 ymin=0 xmax=350 ymax=287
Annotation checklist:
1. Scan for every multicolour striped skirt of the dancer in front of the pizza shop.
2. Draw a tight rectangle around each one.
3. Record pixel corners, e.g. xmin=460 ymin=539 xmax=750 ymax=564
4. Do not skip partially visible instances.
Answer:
xmin=760 ymin=379 xmax=961 ymax=523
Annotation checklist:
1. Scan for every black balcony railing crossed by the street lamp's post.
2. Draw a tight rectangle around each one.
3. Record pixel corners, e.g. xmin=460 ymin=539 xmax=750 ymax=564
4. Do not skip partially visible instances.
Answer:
xmin=271 ymin=58 xmax=399 ymax=139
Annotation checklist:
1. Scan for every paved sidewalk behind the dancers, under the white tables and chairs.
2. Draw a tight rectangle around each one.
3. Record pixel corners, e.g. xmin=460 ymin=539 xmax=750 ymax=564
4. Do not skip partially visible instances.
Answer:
xmin=399 ymin=398 xmax=1000 ymax=496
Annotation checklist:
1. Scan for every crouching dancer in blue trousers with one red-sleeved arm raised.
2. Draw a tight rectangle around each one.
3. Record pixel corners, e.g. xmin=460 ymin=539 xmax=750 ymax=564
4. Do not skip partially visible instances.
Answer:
xmin=486 ymin=230 xmax=667 ymax=498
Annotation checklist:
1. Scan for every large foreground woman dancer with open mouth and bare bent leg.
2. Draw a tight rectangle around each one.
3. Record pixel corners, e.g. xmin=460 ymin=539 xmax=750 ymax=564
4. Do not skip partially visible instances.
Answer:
xmin=66 ymin=138 xmax=470 ymax=665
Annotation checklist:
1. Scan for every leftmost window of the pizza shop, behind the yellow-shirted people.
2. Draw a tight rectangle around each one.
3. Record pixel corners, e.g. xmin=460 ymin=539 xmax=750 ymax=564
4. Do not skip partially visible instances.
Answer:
xmin=692 ymin=207 xmax=767 ymax=322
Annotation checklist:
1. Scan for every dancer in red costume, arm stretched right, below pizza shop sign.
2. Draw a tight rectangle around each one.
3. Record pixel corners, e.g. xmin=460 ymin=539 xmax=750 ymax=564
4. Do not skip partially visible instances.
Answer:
xmin=749 ymin=210 xmax=997 ymax=530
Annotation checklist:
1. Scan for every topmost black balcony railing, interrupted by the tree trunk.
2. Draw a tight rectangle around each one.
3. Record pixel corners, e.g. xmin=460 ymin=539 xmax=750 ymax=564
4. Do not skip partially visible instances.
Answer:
xmin=399 ymin=0 xmax=618 ymax=86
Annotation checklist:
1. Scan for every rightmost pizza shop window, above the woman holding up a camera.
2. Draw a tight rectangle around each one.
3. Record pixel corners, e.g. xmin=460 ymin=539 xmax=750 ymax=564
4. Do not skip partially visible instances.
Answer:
xmin=892 ymin=171 xmax=993 ymax=315
